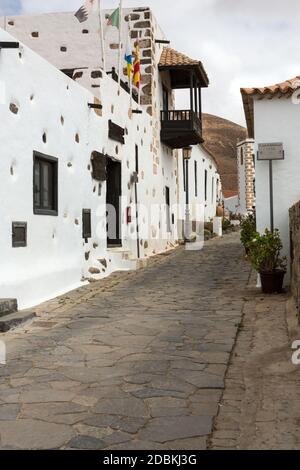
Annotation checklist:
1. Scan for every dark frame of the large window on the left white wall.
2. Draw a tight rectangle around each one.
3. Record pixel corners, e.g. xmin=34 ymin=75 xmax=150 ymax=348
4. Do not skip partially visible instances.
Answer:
xmin=33 ymin=151 xmax=58 ymax=216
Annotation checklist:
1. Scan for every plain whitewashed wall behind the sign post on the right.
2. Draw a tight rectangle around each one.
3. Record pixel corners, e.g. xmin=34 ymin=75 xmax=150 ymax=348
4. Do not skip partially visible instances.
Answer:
xmin=254 ymin=98 xmax=300 ymax=280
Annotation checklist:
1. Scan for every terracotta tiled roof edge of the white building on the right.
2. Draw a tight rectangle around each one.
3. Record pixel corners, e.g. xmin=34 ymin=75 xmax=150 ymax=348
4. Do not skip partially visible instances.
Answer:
xmin=241 ymin=75 xmax=300 ymax=138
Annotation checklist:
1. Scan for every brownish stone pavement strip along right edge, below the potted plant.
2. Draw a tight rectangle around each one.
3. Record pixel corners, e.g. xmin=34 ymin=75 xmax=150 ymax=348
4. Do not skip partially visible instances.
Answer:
xmin=209 ymin=277 xmax=300 ymax=450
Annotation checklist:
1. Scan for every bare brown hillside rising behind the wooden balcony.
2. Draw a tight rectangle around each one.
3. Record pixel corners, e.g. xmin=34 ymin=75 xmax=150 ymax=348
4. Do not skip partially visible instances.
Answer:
xmin=203 ymin=114 xmax=247 ymax=191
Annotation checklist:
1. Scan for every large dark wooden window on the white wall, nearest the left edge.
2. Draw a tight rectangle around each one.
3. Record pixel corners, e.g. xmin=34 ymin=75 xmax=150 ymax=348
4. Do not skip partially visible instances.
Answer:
xmin=33 ymin=152 xmax=58 ymax=215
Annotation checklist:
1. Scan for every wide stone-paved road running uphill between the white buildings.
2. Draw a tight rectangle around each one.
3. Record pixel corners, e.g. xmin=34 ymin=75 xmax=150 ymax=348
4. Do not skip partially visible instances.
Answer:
xmin=0 ymin=234 xmax=249 ymax=450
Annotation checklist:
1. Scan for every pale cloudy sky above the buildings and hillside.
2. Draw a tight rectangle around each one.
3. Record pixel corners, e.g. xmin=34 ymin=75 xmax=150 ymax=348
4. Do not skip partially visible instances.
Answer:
xmin=0 ymin=0 xmax=300 ymax=124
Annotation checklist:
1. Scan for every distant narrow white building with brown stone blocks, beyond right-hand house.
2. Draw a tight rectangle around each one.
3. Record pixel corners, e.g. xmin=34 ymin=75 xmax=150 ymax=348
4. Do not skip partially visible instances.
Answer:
xmin=237 ymin=139 xmax=255 ymax=215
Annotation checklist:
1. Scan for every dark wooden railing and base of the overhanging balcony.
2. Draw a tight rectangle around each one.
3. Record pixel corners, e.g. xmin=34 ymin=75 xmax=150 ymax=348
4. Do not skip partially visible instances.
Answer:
xmin=161 ymin=110 xmax=203 ymax=149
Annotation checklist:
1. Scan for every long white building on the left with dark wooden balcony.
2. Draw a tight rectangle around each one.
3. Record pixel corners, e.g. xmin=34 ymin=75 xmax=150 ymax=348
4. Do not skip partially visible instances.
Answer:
xmin=0 ymin=8 xmax=220 ymax=308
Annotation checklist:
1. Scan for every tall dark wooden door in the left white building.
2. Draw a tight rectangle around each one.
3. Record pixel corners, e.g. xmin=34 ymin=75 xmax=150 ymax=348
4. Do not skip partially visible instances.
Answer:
xmin=106 ymin=160 xmax=122 ymax=245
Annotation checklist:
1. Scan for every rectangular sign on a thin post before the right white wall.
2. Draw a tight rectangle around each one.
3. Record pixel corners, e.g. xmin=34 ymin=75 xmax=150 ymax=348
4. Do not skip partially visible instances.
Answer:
xmin=257 ymin=142 xmax=284 ymax=232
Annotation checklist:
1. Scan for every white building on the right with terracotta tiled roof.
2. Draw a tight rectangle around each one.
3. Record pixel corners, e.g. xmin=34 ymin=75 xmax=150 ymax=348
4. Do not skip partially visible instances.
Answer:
xmin=241 ymin=77 xmax=300 ymax=278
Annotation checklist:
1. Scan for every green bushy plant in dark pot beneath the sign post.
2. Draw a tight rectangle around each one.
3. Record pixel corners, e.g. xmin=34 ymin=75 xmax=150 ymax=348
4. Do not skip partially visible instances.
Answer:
xmin=247 ymin=229 xmax=286 ymax=294
